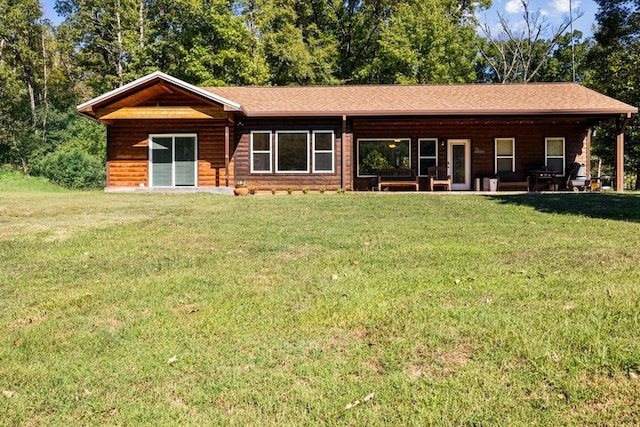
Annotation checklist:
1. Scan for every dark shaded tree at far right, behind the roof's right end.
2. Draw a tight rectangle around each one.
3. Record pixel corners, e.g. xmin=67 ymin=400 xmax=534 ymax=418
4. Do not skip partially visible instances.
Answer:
xmin=586 ymin=0 xmax=640 ymax=189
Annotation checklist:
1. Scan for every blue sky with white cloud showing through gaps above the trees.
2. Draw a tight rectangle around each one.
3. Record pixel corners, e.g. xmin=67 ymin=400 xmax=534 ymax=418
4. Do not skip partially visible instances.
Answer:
xmin=40 ymin=0 xmax=597 ymax=37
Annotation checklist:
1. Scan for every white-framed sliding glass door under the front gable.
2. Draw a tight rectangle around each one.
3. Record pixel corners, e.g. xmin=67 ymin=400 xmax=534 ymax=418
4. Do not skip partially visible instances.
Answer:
xmin=149 ymin=134 xmax=198 ymax=187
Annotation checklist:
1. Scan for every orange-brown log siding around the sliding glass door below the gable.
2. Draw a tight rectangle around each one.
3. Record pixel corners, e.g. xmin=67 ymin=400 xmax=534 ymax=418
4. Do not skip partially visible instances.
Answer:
xmin=107 ymin=120 xmax=233 ymax=187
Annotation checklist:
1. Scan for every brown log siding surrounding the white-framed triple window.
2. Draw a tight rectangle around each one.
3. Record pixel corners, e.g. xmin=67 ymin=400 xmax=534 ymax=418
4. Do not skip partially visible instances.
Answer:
xmin=233 ymin=117 xmax=351 ymax=190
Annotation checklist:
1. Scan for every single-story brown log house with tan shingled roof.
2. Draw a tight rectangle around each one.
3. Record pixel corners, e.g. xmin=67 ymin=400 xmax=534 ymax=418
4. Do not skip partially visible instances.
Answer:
xmin=77 ymin=72 xmax=637 ymax=192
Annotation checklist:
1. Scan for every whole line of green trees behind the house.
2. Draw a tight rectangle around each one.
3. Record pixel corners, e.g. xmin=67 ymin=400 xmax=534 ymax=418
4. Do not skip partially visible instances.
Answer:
xmin=0 ymin=0 xmax=640 ymax=187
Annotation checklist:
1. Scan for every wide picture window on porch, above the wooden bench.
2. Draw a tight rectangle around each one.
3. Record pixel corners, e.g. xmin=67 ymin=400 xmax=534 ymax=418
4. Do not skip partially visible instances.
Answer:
xmin=358 ymin=139 xmax=411 ymax=176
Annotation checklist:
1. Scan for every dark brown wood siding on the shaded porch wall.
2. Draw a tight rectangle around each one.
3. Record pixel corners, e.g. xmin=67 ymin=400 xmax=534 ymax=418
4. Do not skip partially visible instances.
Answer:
xmin=351 ymin=118 xmax=588 ymax=190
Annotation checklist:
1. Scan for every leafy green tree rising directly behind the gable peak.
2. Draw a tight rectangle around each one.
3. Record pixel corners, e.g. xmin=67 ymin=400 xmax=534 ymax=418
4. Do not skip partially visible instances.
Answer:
xmin=135 ymin=0 xmax=267 ymax=86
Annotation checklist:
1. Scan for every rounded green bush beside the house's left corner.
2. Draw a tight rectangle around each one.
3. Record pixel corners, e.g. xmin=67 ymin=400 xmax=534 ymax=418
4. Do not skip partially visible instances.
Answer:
xmin=35 ymin=149 xmax=106 ymax=189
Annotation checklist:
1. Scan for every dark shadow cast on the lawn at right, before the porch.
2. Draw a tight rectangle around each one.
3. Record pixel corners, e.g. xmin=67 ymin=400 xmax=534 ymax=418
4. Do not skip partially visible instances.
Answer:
xmin=487 ymin=192 xmax=640 ymax=222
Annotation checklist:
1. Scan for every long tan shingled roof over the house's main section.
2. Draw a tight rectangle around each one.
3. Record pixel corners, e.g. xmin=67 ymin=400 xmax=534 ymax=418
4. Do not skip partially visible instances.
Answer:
xmin=205 ymin=83 xmax=638 ymax=117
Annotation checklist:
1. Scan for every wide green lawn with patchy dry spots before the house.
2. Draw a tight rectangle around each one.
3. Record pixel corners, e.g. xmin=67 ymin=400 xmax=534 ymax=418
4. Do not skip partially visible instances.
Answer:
xmin=0 ymin=176 xmax=640 ymax=426
